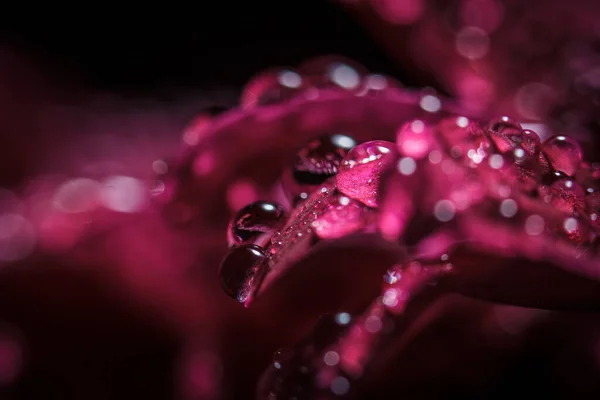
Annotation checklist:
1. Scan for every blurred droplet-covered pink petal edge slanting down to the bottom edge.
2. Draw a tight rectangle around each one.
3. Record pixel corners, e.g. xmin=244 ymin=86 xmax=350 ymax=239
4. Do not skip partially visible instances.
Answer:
xmin=259 ymin=258 xmax=452 ymax=399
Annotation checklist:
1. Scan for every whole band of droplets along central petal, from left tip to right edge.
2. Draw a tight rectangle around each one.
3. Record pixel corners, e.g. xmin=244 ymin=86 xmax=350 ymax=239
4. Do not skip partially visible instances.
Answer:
xmin=220 ymin=103 xmax=599 ymax=312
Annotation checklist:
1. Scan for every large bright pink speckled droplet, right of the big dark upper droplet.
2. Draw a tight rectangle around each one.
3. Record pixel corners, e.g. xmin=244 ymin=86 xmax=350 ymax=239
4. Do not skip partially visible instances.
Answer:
xmin=336 ymin=140 xmax=398 ymax=207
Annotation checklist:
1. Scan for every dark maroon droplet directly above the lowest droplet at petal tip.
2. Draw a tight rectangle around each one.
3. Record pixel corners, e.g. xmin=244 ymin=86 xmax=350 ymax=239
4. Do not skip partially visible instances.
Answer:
xmin=227 ymin=201 xmax=285 ymax=247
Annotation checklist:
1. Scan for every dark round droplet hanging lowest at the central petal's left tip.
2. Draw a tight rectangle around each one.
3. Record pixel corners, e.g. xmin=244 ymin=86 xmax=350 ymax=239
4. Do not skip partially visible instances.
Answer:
xmin=219 ymin=244 xmax=266 ymax=303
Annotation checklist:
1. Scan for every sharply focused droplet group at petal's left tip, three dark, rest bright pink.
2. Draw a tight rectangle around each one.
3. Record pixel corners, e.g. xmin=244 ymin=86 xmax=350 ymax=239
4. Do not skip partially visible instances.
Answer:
xmin=219 ymin=128 xmax=396 ymax=304
